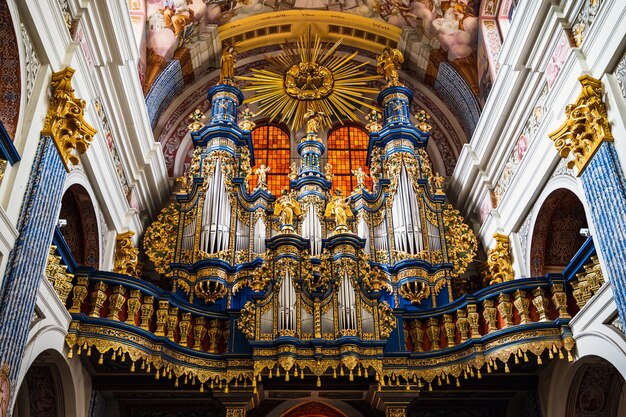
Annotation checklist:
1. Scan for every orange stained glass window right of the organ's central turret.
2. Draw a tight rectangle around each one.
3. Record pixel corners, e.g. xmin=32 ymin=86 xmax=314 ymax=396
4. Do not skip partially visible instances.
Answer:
xmin=328 ymin=126 xmax=372 ymax=195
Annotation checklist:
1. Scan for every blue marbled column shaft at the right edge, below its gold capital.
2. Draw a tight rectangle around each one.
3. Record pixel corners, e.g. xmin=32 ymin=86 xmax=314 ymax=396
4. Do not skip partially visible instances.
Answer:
xmin=580 ymin=142 xmax=626 ymax=320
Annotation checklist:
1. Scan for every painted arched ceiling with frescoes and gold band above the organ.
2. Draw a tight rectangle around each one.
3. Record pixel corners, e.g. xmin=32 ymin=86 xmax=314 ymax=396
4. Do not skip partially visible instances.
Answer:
xmin=128 ymin=0 xmax=480 ymax=175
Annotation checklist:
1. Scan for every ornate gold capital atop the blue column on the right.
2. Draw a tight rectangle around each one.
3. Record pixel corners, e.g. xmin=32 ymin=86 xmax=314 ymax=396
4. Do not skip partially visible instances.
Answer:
xmin=548 ymin=74 xmax=613 ymax=176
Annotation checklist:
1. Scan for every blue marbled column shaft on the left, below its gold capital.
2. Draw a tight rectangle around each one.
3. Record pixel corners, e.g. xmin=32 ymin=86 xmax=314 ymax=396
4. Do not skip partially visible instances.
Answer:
xmin=0 ymin=136 xmax=66 ymax=392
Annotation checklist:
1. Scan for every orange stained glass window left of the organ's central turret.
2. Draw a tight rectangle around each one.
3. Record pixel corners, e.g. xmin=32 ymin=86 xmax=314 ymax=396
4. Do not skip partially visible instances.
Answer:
xmin=249 ymin=125 xmax=291 ymax=195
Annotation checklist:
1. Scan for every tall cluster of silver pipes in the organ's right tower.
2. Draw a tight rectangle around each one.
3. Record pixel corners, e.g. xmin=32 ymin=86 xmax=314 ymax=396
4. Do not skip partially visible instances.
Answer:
xmin=391 ymin=165 xmax=424 ymax=254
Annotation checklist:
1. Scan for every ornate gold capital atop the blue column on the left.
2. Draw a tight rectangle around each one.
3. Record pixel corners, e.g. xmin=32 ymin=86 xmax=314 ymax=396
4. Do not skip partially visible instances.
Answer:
xmin=41 ymin=67 xmax=96 ymax=172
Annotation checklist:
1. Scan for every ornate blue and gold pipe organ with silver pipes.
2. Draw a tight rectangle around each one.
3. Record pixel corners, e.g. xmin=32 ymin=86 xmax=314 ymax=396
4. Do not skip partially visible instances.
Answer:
xmin=140 ymin=74 xmax=475 ymax=374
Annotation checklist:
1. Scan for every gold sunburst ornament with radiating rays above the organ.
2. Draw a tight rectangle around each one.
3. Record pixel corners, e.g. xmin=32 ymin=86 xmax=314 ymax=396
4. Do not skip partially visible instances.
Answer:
xmin=237 ymin=26 xmax=379 ymax=129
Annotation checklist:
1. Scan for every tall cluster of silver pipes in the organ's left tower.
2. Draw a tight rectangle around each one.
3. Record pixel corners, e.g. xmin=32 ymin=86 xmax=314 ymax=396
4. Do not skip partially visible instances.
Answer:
xmin=200 ymin=160 xmax=231 ymax=253
